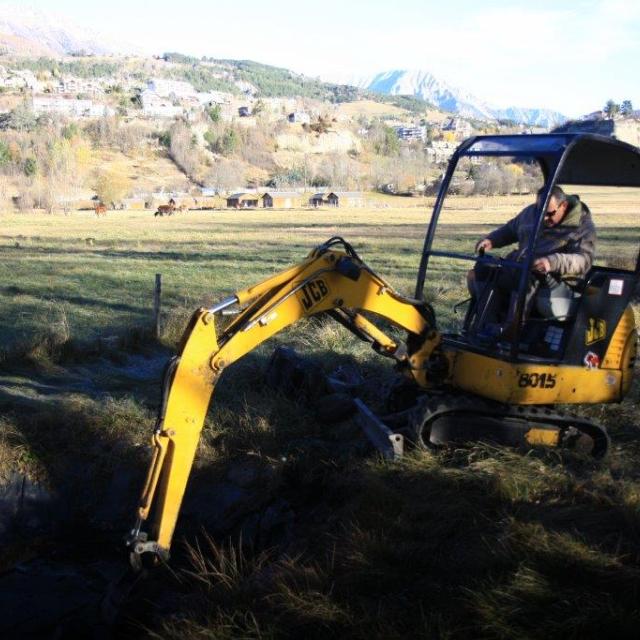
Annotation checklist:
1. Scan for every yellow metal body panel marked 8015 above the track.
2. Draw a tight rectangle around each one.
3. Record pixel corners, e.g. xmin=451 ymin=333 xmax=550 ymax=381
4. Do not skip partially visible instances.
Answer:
xmin=452 ymin=351 xmax=622 ymax=404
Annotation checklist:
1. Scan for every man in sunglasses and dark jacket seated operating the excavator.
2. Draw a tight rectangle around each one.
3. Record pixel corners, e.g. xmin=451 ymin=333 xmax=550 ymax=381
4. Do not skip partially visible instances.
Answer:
xmin=469 ymin=186 xmax=596 ymax=337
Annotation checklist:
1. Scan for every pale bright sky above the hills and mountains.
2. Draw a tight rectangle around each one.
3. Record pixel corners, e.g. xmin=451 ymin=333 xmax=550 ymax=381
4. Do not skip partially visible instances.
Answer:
xmin=6 ymin=0 xmax=640 ymax=116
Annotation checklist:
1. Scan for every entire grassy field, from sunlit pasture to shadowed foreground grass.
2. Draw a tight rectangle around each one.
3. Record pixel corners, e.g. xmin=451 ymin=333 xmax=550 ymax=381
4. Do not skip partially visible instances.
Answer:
xmin=0 ymin=190 xmax=640 ymax=640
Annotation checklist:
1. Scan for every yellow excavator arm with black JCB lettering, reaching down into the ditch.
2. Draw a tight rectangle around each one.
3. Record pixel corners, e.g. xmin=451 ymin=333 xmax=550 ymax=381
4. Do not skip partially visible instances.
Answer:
xmin=127 ymin=238 xmax=440 ymax=568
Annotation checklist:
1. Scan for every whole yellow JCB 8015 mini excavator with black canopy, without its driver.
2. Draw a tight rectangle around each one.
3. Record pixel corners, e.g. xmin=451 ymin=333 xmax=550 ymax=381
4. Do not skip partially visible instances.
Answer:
xmin=128 ymin=134 xmax=640 ymax=567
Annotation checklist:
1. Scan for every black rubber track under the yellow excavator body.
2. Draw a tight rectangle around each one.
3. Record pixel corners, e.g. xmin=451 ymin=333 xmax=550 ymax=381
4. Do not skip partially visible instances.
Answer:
xmin=406 ymin=393 xmax=610 ymax=458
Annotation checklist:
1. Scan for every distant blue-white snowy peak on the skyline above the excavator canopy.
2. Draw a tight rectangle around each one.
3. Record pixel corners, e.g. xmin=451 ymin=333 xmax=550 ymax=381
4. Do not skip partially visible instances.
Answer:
xmin=348 ymin=69 xmax=566 ymax=127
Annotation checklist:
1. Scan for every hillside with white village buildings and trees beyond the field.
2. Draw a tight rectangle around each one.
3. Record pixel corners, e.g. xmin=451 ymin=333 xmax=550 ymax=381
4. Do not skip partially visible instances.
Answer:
xmin=0 ymin=54 xmax=640 ymax=211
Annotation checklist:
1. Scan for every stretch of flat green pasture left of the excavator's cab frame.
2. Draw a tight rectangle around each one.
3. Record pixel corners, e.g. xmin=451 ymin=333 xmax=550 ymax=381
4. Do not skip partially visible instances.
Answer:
xmin=0 ymin=210 xmax=427 ymax=352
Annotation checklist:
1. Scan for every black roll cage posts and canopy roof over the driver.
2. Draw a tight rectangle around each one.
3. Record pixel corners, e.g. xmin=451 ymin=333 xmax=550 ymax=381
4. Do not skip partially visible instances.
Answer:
xmin=415 ymin=133 xmax=640 ymax=358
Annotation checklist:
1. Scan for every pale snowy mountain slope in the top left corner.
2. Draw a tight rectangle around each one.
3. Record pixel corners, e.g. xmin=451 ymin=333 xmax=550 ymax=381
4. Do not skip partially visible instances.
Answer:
xmin=0 ymin=3 xmax=141 ymax=55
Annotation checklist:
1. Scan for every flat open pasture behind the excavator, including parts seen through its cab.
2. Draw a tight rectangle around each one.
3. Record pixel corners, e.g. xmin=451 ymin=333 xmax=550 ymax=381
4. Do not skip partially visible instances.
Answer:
xmin=0 ymin=191 xmax=637 ymax=358
